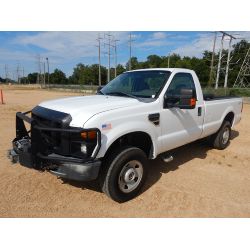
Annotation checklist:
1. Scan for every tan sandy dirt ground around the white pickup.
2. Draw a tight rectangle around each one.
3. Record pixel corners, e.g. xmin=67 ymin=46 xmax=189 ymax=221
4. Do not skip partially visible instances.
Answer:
xmin=0 ymin=89 xmax=250 ymax=217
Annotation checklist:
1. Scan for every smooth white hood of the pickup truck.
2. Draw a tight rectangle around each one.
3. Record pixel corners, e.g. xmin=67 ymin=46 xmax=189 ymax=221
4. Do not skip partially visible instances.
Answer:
xmin=39 ymin=95 xmax=140 ymax=127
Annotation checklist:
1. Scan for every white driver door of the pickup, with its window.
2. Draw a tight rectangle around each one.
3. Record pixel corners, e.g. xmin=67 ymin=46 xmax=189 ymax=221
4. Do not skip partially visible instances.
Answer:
xmin=160 ymin=73 xmax=204 ymax=152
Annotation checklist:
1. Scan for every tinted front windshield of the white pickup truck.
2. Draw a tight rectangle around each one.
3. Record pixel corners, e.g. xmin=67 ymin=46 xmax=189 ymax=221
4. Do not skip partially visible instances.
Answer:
xmin=101 ymin=70 xmax=170 ymax=98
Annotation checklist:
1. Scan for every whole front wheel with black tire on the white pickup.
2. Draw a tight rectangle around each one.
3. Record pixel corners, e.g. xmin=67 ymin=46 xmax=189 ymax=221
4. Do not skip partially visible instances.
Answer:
xmin=100 ymin=147 xmax=148 ymax=203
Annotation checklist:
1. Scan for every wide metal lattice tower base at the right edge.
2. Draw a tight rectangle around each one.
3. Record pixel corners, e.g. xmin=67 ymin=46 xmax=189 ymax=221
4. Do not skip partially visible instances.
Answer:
xmin=233 ymin=47 xmax=250 ymax=88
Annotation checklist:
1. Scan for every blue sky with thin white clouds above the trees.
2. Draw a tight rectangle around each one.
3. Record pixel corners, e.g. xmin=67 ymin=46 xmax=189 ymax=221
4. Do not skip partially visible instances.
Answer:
xmin=0 ymin=31 xmax=250 ymax=79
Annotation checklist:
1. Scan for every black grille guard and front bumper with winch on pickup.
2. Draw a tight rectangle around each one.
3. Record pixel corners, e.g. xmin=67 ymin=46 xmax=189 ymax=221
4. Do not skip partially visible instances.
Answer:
xmin=8 ymin=108 xmax=101 ymax=181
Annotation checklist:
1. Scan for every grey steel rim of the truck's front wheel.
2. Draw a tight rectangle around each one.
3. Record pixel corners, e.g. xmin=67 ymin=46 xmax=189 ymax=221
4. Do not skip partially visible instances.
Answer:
xmin=118 ymin=160 xmax=143 ymax=193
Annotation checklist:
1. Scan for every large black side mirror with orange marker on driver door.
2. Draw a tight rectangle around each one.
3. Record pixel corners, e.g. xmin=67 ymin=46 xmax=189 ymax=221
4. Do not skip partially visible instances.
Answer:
xmin=164 ymin=88 xmax=196 ymax=109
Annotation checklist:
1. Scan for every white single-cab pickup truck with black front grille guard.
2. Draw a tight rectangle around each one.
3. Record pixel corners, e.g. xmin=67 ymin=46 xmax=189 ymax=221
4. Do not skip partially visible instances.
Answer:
xmin=9 ymin=68 xmax=243 ymax=202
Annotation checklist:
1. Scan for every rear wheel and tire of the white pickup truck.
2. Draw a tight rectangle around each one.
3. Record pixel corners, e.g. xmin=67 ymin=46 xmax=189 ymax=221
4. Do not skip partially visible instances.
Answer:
xmin=210 ymin=121 xmax=231 ymax=150
